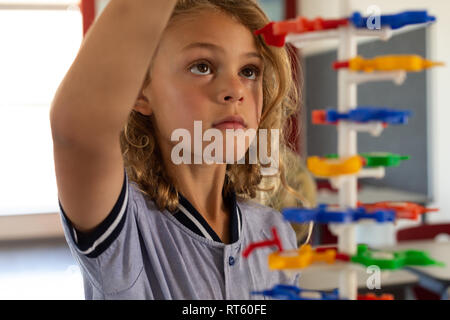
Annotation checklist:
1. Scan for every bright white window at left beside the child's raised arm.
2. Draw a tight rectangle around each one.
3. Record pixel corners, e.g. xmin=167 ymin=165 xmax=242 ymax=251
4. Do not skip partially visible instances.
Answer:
xmin=0 ymin=0 xmax=83 ymax=238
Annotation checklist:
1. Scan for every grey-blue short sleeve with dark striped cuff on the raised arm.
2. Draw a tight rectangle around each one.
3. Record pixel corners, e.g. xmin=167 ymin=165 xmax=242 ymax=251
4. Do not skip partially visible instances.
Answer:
xmin=59 ymin=171 xmax=143 ymax=296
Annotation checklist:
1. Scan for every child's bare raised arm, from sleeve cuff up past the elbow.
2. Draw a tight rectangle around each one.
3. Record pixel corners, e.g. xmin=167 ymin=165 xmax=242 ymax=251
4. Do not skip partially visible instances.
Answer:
xmin=50 ymin=0 xmax=176 ymax=232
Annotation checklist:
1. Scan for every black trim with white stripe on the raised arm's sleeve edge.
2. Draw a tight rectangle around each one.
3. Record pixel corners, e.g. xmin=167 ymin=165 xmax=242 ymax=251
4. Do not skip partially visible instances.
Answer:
xmin=58 ymin=172 xmax=128 ymax=258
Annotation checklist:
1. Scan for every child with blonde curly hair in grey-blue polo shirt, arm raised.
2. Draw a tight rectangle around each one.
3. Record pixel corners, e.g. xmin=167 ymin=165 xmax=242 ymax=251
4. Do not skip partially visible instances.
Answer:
xmin=50 ymin=0 xmax=310 ymax=299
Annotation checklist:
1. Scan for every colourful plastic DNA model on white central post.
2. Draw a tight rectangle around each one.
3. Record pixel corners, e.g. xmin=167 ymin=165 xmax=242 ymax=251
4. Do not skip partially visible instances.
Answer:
xmin=243 ymin=4 xmax=443 ymax=300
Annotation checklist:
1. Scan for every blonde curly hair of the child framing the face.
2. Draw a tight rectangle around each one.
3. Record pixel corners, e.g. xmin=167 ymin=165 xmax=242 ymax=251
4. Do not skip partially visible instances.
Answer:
xmin=120 ymin=0 xmax=312 ymax=242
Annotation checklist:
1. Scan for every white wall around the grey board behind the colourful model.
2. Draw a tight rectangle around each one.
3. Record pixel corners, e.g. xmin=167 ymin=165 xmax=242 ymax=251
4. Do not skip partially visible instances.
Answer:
xmin=299 ymin=0 xmax=450 ymax=222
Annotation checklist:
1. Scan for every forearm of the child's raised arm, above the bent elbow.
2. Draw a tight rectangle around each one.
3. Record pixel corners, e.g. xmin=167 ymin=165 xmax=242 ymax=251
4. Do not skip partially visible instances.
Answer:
xmin=50 ymin=0 xmax=176 ymax=143
